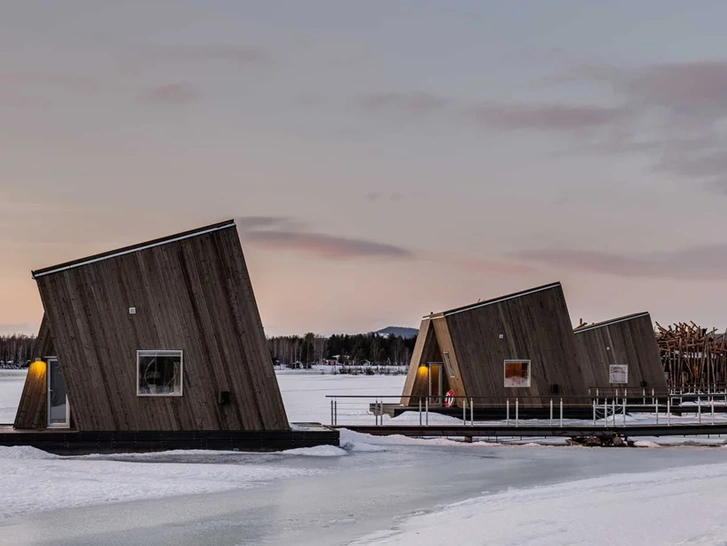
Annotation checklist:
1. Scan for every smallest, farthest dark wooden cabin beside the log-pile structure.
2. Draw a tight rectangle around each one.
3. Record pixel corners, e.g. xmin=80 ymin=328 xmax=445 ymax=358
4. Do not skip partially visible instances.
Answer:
xmin=573 ymin=312 xmax=667 ymax=393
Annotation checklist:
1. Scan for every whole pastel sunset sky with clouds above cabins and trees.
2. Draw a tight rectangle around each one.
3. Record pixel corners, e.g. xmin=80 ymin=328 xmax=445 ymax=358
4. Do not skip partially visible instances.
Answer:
xmin=0 ymin=0 xmax=727 ymax=335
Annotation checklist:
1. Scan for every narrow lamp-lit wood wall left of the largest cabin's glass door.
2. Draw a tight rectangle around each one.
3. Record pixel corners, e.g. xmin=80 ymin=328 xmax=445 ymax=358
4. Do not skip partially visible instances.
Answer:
xmin=13 ymin=316 xmax=55 ymax=429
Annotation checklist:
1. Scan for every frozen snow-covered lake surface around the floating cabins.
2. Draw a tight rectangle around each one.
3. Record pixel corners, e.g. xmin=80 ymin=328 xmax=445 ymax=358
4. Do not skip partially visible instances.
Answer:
xmin=0 ymin=372 xmax=727 ymax=546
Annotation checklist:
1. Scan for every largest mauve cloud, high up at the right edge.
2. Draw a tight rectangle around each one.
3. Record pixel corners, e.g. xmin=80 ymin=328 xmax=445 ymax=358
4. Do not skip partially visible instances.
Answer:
xmin=536 ymin=59 xmax=727 ymax=193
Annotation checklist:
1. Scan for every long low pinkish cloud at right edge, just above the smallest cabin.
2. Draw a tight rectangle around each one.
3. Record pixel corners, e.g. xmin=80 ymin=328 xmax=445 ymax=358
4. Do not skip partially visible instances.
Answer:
xmin=513 ymin=243 xmax=727 ymax=280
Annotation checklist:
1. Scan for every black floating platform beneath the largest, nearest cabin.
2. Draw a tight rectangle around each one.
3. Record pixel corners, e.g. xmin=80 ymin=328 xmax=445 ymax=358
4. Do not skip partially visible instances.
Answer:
xmin=0 ymin=426 xmax=340 ymax=455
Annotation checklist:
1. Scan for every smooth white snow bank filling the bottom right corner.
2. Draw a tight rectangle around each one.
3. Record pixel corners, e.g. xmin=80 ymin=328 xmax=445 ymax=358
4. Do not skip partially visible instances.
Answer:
xmin=352 ymin=464 xmax=727 ymax=546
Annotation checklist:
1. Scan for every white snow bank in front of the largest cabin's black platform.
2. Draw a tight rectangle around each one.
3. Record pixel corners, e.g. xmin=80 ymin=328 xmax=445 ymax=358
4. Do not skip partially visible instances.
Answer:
xmin=0 ymin=448 xmax=324 ymax=521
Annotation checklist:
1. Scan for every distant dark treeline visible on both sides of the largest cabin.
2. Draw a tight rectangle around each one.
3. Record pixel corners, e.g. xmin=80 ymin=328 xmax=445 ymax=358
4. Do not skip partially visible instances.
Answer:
xmin=0 ymin=333 xmax=416 ymax=368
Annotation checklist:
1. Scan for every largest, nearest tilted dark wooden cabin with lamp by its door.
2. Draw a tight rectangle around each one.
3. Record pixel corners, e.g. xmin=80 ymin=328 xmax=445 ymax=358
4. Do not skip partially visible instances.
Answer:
xmin=14 ymin=221 xmax=290 ymax=432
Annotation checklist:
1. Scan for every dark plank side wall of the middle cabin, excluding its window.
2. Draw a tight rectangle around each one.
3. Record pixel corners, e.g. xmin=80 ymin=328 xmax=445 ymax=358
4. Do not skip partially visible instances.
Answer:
xmin=444 ymin=284 xmax=592 ymax=405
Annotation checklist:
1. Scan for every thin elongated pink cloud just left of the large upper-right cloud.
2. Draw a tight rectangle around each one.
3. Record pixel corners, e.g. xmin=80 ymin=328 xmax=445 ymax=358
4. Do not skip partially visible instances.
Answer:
xmin=469 ymin=104 xmax=627 ymax=131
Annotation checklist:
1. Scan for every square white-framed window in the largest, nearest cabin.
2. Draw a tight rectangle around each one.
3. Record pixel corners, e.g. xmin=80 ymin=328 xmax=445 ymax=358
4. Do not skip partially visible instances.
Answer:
xmin=136 ymin=351 xmax=183 ymax=396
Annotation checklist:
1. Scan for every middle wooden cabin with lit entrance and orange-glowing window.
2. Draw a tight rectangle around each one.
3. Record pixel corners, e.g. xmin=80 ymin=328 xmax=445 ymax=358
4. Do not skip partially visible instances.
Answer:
xmin=401 ymin=283 xmax=593 ymax=407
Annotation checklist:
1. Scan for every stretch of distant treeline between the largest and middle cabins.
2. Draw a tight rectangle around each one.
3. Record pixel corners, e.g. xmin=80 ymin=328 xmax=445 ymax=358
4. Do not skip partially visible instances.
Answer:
xmin=268 ymin=333 xmax=416 ymax=368
